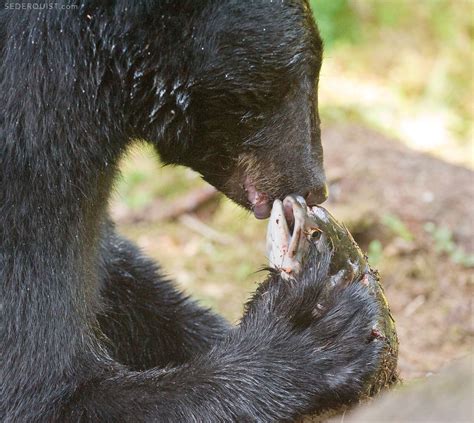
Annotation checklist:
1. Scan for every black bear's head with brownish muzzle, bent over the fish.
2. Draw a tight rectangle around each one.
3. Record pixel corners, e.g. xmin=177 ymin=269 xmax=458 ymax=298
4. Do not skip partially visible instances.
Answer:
xmin=123 ymin=0 xmax=327 ymax=218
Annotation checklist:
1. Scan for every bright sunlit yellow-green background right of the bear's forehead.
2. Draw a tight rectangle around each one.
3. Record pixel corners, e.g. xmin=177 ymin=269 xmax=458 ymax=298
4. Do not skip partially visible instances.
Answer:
xmin=311 ymin=0 xmax=474 ymax=167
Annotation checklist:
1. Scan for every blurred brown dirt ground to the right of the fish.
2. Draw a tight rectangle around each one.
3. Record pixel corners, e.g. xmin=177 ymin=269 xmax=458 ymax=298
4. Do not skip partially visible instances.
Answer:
xmin=324 ymin=126 xmax=474 ymax=379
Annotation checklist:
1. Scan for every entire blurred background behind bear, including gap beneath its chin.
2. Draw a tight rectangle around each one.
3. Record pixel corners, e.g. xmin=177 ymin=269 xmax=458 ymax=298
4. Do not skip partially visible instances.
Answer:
xmin=111 ymin=0 xmax=474 ymax=379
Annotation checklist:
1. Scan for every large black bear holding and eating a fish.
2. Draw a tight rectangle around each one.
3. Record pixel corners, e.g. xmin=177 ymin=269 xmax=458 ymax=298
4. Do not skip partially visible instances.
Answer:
xmin=0 ymin=0 xmax=379 ymax=422
